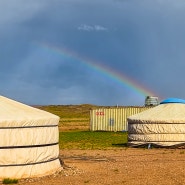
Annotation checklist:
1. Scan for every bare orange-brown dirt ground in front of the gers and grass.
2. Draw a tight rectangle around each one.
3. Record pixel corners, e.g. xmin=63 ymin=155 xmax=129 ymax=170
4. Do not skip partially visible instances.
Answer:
xmin=11 ymin=148 xmax=185 ymax=185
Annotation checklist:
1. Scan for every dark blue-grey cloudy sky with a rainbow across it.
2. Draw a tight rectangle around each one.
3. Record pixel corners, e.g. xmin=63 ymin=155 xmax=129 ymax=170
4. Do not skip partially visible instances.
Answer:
xmin=0 ymin=0 xmax=185 ymax=105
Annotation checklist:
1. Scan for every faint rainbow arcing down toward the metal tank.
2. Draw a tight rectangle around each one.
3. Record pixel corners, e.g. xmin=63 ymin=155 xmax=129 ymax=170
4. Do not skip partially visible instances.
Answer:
xmin=36 ymin=42 xmax=156 ymax=96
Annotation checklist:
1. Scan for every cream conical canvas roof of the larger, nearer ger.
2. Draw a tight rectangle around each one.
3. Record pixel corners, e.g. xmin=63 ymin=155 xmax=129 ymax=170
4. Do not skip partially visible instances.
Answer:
xmin=0 ymin=96 xmax=59 ymax=127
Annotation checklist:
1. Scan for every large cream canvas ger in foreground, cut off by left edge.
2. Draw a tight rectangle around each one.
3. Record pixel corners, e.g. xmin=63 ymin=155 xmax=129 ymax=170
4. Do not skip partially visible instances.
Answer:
xmin=0 ymin=96 xmax=61 ymax=179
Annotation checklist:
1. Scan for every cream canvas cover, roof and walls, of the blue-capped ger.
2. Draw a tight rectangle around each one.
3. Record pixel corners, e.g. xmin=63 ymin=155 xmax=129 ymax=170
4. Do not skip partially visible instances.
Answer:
xmin=127 ymin=103 xmax=185 ymax=146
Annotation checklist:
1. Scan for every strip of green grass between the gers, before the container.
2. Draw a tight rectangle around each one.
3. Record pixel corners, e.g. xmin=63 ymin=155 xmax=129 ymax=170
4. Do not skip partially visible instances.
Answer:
xmin=59 ymin=131 xmax=127 ymax=149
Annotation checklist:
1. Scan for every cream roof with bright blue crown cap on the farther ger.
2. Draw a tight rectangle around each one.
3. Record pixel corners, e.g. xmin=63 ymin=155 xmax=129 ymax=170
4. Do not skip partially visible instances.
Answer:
xmin=128 ymin=98 xmax=185 ymax=123
